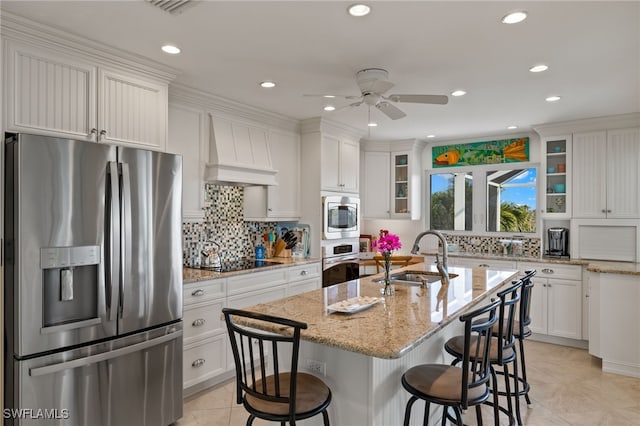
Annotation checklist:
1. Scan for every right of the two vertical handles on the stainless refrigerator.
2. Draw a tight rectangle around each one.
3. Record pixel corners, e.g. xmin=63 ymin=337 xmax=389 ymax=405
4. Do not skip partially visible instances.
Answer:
xmin=120 ymin=163 xmax=133 ymax=318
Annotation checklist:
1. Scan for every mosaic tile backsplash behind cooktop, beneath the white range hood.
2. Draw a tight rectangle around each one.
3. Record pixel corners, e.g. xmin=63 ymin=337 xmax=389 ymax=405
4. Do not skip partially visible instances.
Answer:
xmin=182 ymin=184 xmax=277 ymax=266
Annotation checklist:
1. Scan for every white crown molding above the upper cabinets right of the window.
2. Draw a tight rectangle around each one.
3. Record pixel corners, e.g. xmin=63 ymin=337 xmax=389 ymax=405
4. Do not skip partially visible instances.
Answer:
xmin=531 ymin=112 xmax=640 ymax=136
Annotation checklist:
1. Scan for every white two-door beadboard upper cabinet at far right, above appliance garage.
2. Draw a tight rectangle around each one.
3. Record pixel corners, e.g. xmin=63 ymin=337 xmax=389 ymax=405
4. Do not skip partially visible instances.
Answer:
xmin=573 ymin=128 xmax=640 ymax=219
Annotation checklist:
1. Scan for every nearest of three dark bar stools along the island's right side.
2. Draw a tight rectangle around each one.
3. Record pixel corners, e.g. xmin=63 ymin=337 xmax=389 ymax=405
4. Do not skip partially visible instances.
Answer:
xmin=402 ymin=300 xmax=500 ymax=426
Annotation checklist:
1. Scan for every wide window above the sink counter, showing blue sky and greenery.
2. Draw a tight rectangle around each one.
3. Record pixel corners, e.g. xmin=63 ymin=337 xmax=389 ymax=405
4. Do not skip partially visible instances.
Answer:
xmin=428 ymin=164 xmax=538 ymax=233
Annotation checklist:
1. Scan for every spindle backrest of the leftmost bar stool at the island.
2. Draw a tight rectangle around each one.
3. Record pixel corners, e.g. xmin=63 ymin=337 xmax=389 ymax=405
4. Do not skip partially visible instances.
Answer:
xmin=222 ymin=308 xmax=307 ymax=424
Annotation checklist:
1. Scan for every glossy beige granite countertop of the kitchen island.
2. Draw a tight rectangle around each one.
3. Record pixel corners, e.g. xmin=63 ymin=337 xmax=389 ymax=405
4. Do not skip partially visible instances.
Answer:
xmin=222 ymin=263 xmax=517 ymax=359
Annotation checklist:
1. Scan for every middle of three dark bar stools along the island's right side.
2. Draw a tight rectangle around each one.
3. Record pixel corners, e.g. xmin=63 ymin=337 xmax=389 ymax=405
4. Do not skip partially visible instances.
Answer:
xmin=444 ymin=280 xmax=523 ymax=426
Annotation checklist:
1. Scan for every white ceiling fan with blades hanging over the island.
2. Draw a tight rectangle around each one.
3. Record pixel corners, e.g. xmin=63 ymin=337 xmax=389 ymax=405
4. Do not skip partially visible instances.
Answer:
xmin=304 ymin=68 xmax=449 ymax=120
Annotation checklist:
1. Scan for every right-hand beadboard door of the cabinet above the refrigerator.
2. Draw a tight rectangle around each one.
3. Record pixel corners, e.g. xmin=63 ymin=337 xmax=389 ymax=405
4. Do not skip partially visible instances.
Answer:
xmin=98 ymin=69 xmax=168 ymax=151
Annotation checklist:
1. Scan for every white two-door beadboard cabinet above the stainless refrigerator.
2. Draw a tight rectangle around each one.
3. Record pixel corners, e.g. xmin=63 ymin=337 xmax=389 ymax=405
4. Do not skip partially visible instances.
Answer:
xmin=5 ymin=40 xmax=168 ymax=151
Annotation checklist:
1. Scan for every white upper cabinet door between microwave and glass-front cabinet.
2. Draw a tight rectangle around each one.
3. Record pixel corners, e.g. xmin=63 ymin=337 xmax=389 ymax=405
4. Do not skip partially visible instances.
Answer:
xmin=362 ymin=151 xmax=391 ymax=219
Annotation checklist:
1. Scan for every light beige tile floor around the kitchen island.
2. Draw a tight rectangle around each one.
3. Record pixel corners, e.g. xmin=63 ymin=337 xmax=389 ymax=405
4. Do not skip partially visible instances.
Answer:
xmin=178 ymin=340 xmax=640 ymax=426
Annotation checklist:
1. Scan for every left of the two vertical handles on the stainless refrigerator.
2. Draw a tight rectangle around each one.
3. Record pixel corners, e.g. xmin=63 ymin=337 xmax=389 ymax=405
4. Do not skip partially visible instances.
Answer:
xmin=105 ymin=161 xmax=120 ymax=321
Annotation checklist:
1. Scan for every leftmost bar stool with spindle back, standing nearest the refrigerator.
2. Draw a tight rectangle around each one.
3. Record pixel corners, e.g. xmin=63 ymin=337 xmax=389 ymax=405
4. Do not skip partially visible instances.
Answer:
xmin=222 ymin=308 xmax=331 ymax=426
